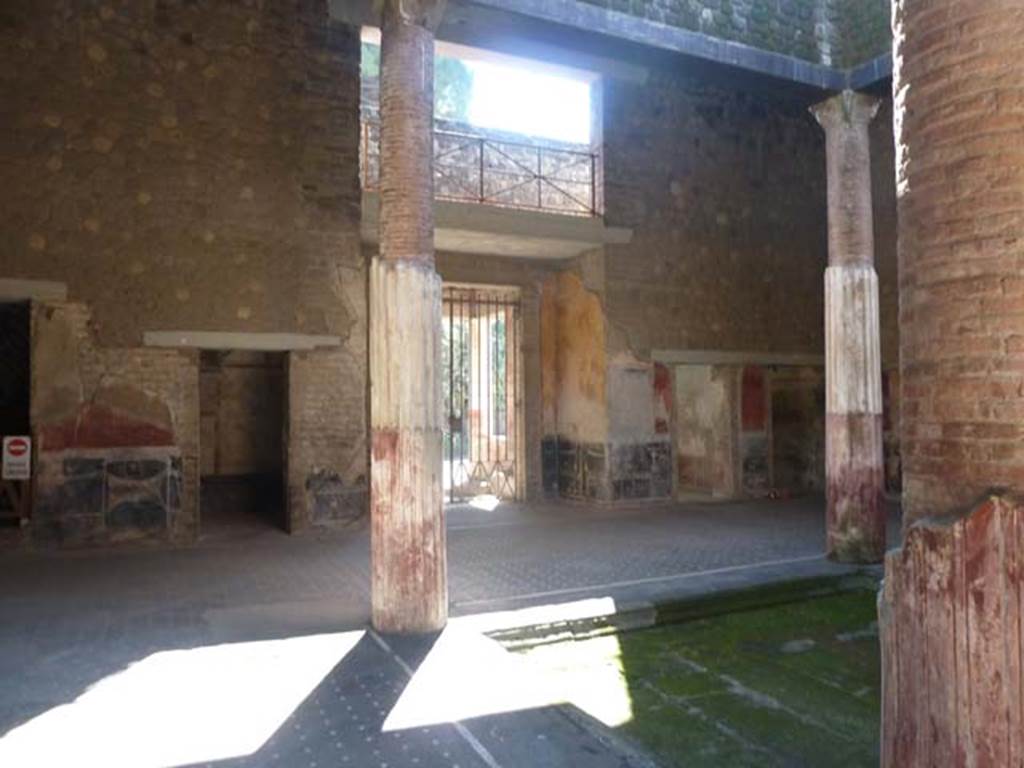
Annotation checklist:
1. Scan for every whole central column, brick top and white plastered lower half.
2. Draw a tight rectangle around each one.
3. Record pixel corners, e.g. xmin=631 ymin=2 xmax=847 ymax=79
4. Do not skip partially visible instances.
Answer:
xmin=370 ymin=0 xmax=447 ymax=633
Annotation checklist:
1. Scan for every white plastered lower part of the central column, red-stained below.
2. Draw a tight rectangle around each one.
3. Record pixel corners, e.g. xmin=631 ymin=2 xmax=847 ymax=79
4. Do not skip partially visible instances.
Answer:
xmin=370 ymin=259 xmax=447 ymax=632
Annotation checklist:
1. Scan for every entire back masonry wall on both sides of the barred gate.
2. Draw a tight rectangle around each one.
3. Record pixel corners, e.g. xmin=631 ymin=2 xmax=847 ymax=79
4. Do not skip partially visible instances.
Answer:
xmin=0 ymin=0 xmax=899 ymax=544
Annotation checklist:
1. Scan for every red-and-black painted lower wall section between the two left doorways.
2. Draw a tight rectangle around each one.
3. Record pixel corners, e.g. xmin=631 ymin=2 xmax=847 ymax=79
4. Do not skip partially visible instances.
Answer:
xmin=31 ymin=302 xmax=199 ymax=544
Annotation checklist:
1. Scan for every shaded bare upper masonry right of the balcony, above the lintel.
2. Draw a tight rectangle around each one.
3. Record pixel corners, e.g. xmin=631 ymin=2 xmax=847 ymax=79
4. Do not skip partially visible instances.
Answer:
xmin=604 ymin=73 xmax=897 ymax=364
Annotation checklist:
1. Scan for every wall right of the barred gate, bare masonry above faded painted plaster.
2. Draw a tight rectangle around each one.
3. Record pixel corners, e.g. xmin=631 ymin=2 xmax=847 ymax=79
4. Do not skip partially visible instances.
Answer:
xmin=546 ymin=69 xmax=898 ymax=505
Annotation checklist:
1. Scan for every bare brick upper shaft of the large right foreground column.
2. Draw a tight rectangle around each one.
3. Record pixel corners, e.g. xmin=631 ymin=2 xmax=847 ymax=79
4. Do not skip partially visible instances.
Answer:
xmin=895 ymin=0 xmax=1024 ymax=524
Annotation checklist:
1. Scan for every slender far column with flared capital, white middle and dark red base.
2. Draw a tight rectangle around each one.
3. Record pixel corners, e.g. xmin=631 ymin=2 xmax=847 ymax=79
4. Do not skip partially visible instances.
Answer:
xmin=812 ymin=91 xmax=886 ymax=562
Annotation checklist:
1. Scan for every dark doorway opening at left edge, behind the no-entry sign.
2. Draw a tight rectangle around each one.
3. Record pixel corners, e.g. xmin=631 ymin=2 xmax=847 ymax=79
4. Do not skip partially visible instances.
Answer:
xmin=0 ymin=301 xmax=32 ymax=527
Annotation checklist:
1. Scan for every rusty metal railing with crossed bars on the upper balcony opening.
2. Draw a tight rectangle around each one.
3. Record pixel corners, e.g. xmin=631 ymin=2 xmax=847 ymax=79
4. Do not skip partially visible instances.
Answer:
xmin=360 ymin=122 xmax=599 ymax=216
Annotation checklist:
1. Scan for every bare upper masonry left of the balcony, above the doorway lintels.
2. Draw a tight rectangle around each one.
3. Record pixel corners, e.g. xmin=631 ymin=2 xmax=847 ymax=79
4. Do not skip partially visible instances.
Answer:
xmin=0 ymin=0 xmax=359 ymax=344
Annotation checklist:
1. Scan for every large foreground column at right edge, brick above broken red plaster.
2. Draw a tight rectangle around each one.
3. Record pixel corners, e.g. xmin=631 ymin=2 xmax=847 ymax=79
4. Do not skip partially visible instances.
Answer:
xmin=880 ymin=0 xmax=1024 ymax=768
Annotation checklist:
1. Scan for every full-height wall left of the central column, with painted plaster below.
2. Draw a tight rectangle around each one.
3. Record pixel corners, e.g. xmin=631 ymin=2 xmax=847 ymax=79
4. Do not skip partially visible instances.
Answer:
xmin=0 ymin=0 xmax=368 ymax=543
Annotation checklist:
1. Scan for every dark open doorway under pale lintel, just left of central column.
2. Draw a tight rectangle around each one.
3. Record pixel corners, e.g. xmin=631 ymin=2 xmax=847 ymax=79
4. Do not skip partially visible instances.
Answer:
xmin=200 ymin=350 xmax=287 ymax=536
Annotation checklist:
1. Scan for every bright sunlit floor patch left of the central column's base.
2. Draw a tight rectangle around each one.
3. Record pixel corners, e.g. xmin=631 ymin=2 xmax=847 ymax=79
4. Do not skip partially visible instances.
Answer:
xmin=0 ymin=632 xmax=364 ymax=768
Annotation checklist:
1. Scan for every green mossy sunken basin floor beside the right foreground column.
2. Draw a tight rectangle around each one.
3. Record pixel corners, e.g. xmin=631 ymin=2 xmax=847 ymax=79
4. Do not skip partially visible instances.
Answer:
xmin=519 ymin=590 xmax=881 ymax=768
